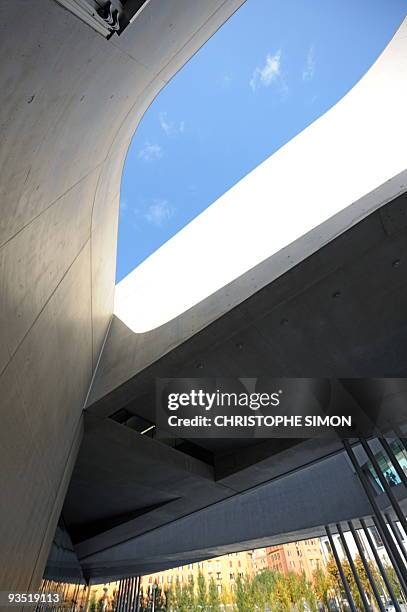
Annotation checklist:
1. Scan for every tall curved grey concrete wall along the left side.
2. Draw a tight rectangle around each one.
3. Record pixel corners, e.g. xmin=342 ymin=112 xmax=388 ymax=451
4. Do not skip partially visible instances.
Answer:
xmin=0 ymin=0 xmax=243 ymax=590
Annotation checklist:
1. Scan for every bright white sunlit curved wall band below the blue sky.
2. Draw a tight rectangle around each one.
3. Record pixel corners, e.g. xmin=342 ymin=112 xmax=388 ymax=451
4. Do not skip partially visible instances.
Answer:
xmin=114 ymin=18 xmax=407 ymax=333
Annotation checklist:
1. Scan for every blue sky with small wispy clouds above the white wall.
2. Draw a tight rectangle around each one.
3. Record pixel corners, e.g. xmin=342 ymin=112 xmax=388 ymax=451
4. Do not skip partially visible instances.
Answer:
xmin=116 ymin=0 xmax=407 ymax=281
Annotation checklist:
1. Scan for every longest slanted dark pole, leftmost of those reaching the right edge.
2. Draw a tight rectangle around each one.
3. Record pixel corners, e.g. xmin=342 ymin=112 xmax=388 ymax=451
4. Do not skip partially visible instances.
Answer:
xmin=343 ymin=440 xmax=407 ymax=596
